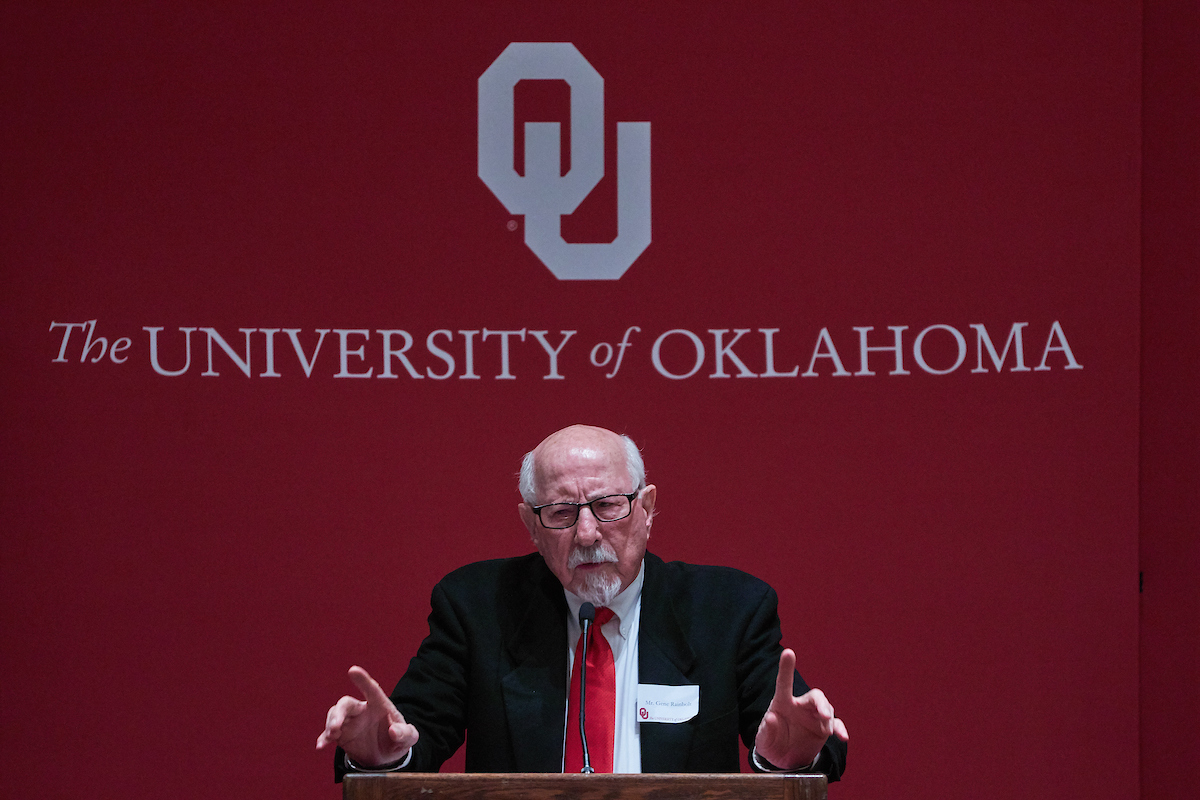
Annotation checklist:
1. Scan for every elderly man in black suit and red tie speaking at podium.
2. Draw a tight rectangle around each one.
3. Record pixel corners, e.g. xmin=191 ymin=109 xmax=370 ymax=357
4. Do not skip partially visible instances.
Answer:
xmin=317 ymin=426 xmax=848 ymax=780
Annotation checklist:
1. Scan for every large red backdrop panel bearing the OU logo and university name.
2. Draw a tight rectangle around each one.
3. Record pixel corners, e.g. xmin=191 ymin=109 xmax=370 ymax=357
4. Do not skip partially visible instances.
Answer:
xmin=0 ymin=1 xmax=1185 ymax=799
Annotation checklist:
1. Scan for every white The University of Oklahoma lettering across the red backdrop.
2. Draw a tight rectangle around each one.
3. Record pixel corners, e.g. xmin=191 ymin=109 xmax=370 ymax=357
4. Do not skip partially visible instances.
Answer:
xmin=56 ymin=319 xmax=1084 ymax=380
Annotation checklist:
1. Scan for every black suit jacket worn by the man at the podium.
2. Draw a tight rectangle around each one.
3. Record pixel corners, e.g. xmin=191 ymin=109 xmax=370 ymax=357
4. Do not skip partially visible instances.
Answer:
xmin=337 ymin=553 xmax=846 ymax=780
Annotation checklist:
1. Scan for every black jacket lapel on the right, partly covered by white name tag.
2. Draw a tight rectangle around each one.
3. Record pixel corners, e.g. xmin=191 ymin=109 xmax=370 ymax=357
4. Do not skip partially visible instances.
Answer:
xmin=637 ymin=553 xmax=703 ymax=772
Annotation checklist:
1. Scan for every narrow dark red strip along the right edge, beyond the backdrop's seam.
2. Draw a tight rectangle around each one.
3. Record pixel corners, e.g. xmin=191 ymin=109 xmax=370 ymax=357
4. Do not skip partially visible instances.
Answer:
xmin=1139 ymin=0 xmax=1200 ymax=800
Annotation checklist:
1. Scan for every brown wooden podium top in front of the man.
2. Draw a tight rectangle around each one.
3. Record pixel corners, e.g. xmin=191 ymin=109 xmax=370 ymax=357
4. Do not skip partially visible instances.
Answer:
xmin=342 ymin=772 xmax=828 ymax=800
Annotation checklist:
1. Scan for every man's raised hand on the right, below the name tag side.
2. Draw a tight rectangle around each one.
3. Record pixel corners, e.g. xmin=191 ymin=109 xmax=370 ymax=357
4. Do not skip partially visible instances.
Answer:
xmin=754 ymin=650 xmax=850 ymax=770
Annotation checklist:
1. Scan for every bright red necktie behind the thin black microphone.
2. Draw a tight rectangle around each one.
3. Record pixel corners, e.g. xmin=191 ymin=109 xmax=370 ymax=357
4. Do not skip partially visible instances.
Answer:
xmin=563 ymin=608 xmax=617 ymax=772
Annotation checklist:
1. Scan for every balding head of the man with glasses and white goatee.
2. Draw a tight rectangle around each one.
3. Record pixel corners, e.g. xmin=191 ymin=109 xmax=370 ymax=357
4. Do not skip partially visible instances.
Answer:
xmin=517 ymin=425 xmax=656 ymax=606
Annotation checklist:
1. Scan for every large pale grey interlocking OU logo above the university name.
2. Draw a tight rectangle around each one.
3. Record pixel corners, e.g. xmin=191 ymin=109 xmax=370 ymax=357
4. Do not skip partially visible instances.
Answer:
xmin=479 ymin=42 xmax=650 ymax=281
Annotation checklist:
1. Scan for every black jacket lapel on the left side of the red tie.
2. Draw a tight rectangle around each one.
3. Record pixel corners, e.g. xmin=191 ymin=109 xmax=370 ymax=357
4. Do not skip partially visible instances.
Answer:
xmin=500 ymin=557 xmax=566 ymax=772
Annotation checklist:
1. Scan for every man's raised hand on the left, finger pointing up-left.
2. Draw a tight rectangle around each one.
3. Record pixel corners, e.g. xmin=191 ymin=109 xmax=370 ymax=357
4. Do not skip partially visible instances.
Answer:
xmin=317 ymin=667 xmax=418 ymax=766
